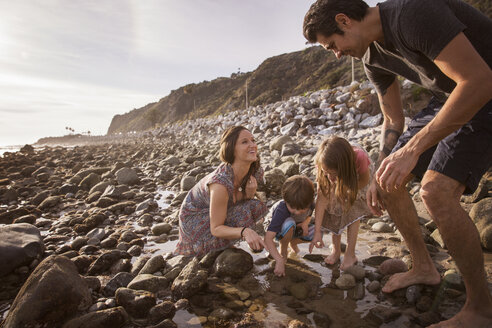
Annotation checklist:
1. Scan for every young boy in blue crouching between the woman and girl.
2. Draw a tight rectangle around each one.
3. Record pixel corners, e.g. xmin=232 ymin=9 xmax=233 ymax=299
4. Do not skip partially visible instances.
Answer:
xmin=265 ymin=175 xmax=314 ymax=277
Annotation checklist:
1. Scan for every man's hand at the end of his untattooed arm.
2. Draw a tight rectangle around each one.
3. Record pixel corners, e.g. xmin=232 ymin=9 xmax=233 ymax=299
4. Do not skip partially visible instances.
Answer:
xmin=374 ymin=147 xmax=419 ymax=192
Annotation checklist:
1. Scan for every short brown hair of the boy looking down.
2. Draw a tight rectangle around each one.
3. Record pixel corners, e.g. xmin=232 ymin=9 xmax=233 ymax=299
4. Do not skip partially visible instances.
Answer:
xmin=282 ymin=175 xmax=314 ymax=210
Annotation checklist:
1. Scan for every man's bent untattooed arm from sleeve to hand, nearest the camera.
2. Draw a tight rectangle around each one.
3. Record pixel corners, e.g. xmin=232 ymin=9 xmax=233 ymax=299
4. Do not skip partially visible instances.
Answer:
xmin=376 ymin=33 xmax=492 ymax=191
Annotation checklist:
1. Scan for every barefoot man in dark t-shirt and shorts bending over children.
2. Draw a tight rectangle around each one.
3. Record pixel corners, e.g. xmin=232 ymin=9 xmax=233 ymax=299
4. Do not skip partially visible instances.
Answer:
xmin=303 ymin=0 xmax=492 ymax=327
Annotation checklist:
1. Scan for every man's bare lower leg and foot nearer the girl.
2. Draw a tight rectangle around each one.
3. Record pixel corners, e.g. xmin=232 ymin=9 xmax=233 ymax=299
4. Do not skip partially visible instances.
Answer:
xmin=379 ymin=177 xmax=441 ymax=293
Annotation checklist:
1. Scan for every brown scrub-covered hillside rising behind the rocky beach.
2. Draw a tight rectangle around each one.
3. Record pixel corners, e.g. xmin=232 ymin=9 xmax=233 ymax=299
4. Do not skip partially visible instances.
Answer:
xmin=108 ymin=0 xmax=492 ymax=134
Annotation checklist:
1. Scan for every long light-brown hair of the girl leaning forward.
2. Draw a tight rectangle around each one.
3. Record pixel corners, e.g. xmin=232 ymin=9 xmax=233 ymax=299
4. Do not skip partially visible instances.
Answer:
xmin=314 ymin=137 xmax=359 ymax=210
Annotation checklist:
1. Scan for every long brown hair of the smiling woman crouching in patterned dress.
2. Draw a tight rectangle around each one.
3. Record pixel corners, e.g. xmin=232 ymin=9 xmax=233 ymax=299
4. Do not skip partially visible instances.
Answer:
xmin=219 ymin=125 xmax=261 ymax=195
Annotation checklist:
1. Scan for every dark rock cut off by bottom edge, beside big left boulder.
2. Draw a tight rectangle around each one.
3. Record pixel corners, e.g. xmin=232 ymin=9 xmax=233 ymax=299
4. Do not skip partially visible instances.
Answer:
xmin=63 ymin=306 xmax=128 ymax=328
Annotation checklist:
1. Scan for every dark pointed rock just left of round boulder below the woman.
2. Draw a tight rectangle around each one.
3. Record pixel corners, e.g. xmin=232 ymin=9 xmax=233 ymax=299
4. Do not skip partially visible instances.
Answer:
xmin=171 ymin=258 xmax=208 ymax=300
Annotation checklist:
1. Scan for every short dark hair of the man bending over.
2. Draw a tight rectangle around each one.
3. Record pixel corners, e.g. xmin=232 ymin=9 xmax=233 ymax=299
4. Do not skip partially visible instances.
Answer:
xmin=303 ymin=0 xmax=369 ymax=43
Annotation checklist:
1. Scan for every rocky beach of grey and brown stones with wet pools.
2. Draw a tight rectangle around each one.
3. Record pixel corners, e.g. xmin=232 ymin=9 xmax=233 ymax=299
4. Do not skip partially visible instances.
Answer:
xmin=0 ymin=81 xmax=492 ymax=328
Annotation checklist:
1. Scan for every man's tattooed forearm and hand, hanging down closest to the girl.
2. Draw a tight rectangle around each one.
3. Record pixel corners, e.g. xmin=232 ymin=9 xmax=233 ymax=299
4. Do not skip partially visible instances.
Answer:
xmin=366 ymin=78 xmax=405 ymax=215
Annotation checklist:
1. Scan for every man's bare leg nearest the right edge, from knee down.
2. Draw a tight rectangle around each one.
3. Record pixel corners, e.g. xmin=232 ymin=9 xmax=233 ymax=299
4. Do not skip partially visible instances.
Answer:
xmin=420 ymin=171 xmax=492 ymax=328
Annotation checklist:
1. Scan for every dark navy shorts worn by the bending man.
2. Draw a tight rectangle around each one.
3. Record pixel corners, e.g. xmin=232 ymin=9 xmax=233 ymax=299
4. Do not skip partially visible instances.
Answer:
xmin=392 ymin=98 xmax=492 ymax=194
